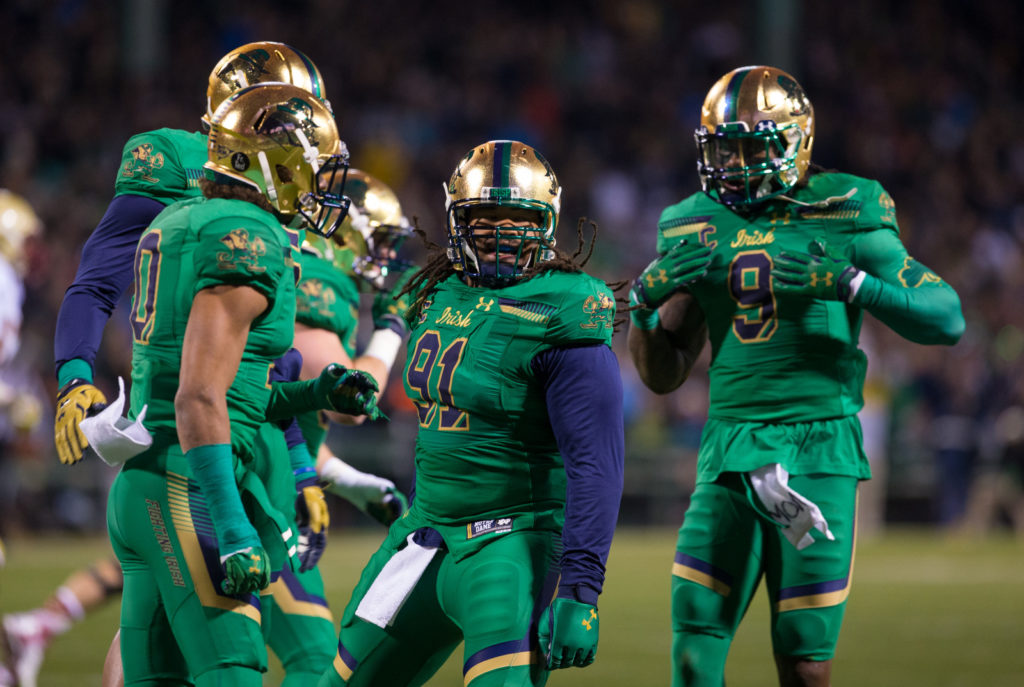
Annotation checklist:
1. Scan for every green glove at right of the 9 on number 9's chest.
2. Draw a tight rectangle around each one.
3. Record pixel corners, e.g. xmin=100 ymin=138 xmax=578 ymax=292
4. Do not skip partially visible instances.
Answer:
xmin=771 ymin=239 xmax=864 ymax=303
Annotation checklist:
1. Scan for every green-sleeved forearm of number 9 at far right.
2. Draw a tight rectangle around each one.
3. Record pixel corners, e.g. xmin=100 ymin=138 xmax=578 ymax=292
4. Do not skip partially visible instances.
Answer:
xmin=854 ymin=273 xmax=966 ymax=346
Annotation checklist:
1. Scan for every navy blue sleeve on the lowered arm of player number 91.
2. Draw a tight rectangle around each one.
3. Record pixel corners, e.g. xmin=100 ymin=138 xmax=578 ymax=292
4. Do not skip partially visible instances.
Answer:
xmin=532 ymin=344 xmax=625 ymax=605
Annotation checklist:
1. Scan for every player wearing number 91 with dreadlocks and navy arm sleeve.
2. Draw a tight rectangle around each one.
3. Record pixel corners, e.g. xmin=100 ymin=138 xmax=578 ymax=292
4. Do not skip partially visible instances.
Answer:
xmin=319 ymin=140 xmax=623 ymax=687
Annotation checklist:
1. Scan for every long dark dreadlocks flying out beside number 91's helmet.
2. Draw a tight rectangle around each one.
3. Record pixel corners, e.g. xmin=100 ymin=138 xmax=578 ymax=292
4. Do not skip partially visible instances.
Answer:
xmin=398 ymin=217 xmax=629 ymax=331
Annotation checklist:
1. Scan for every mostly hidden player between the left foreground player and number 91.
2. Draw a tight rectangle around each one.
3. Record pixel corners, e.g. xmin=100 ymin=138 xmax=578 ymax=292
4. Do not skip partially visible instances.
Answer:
xmin=258 ymin=169 xmax=411 ymax=687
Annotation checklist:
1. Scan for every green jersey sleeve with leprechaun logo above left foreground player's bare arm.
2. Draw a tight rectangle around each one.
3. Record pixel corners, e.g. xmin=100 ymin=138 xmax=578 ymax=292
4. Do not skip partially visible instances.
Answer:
xmin=194 ymin=216 xmax=294 ymax=305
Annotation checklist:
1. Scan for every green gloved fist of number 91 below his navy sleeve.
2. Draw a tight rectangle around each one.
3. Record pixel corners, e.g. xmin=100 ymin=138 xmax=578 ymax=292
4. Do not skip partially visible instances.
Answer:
xmin=538 ymin=597 xmax=600 ymax=670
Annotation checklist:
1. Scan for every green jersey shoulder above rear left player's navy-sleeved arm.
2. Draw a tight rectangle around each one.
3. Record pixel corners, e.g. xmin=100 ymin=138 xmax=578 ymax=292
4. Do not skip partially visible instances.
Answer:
xmin=114 ymin=129 xmax=208 ymax=205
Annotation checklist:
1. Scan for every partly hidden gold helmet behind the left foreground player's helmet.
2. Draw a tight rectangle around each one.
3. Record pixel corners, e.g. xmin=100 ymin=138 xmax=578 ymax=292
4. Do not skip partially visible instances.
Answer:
xmin=203 ymin=41 xmax=331 ymax=126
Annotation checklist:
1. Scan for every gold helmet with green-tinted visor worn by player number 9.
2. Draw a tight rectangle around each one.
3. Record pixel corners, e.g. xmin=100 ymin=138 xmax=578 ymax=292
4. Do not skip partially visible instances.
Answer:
xmin=694 ymin=66 xmax=814 ymax=206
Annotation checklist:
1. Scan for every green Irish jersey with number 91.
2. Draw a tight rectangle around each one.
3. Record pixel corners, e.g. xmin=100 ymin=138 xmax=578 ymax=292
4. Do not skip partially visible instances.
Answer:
xmin=403 ymin=271 xmax=615 ymax=528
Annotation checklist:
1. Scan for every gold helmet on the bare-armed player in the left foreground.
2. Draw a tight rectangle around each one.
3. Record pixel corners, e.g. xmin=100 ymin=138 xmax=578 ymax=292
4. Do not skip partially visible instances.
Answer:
xmin=204 ymin=82 xmax=349 ymax=237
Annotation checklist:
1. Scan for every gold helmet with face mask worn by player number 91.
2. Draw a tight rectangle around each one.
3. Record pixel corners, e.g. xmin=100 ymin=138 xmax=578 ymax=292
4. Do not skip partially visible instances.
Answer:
xmin=444 ymin=140 xmax=562 ymax=286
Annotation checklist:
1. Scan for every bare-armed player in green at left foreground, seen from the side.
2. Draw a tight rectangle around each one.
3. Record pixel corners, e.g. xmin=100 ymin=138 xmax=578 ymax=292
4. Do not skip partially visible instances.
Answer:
xmin=108 ymin=82 xmax=376 ymax=686
